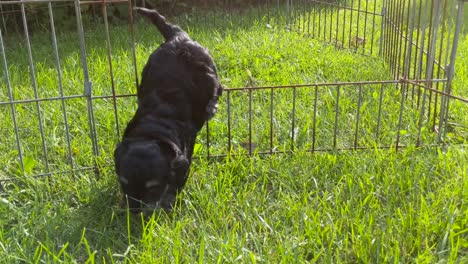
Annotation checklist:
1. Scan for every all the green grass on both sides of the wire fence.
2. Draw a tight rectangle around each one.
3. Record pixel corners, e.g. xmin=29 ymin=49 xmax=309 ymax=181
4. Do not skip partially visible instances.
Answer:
xmin=0 ymin=2 xmax=468 ymax=263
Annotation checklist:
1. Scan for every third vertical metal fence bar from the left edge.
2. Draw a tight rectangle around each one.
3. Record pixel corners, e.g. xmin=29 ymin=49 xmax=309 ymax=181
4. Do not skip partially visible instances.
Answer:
xmin=48 ymin=2 xmax=74 ymax=169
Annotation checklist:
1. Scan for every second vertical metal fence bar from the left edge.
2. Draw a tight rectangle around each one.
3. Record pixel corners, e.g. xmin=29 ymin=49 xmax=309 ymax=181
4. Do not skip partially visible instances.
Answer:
xmin=21 ymin=3 xmax=50 ymax=172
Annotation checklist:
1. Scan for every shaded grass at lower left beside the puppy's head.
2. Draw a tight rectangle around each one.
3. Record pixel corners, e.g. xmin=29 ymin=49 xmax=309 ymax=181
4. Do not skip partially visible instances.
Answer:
xmin=0 ymin=167 xmax=176 ymax=263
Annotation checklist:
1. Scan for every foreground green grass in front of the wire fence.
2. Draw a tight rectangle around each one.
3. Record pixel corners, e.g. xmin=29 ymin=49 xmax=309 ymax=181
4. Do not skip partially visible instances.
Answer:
xmin=0 ymin=148 xmax=468 ymax=263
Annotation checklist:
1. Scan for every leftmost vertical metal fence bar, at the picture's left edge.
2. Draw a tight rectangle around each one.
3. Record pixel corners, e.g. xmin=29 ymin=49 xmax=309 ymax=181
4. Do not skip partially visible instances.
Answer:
xmin=0 ymin=29 xmax=24 ymax=175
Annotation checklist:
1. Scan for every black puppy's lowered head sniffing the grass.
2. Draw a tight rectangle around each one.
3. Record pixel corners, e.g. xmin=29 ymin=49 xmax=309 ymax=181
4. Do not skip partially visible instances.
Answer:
xmin=114 ymin=140 xmax=189 ymax=212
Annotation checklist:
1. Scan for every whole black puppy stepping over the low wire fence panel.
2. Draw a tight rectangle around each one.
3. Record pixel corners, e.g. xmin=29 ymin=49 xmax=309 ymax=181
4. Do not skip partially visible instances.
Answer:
xmin=114 ymin=8 xmax=222 ymax=212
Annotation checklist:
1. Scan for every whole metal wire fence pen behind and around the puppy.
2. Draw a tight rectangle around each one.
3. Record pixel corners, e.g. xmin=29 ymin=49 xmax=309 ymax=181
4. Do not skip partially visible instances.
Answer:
xmin=0 ymin=0 xmax=468 ymax=181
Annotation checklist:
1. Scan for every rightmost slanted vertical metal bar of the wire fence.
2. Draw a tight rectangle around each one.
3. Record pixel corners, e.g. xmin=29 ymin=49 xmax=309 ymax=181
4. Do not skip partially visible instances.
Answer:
xmin=440 ymin=0 xmax=464 ymax=142
